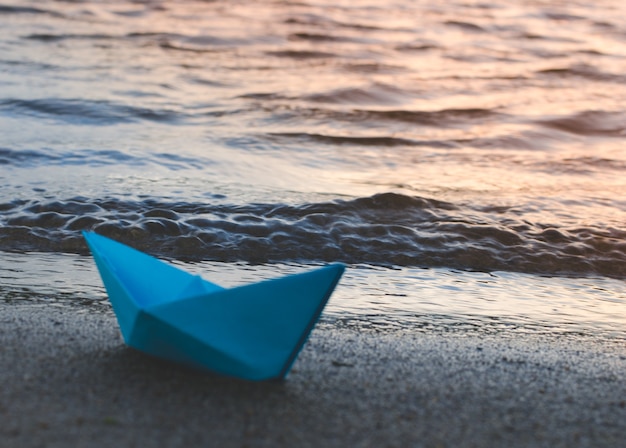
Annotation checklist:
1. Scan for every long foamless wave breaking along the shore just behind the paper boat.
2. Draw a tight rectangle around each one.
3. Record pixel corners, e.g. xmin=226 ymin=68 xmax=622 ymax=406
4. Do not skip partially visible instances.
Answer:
xmin=0 ymin=193 xmax=626 ymax=278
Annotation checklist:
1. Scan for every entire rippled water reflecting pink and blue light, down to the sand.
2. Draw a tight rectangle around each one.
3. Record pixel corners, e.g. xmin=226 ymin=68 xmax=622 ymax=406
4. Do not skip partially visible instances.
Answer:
xmin=0 ymin=0 xmax=626 ymax=338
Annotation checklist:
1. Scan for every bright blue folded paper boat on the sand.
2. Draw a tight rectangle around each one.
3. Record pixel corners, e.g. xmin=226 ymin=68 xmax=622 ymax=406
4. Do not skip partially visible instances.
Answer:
xmin=83 ymin=232 xmax=344 ymax=380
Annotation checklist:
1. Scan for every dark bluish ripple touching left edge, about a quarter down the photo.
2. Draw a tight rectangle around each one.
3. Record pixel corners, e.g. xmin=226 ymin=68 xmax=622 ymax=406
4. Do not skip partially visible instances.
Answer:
xmin=0 ymin=98 xmax=182 ymax=125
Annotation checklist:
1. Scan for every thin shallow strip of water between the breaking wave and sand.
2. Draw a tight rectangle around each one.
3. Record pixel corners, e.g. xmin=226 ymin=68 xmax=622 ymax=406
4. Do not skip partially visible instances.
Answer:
xmin=0 ymin=253 xmax=626 ymax=340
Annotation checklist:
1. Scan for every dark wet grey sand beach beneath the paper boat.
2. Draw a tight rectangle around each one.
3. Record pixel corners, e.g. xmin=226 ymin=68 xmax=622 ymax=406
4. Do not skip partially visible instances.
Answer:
xmin=0 ymin=303 xmax=626 ymax=448
